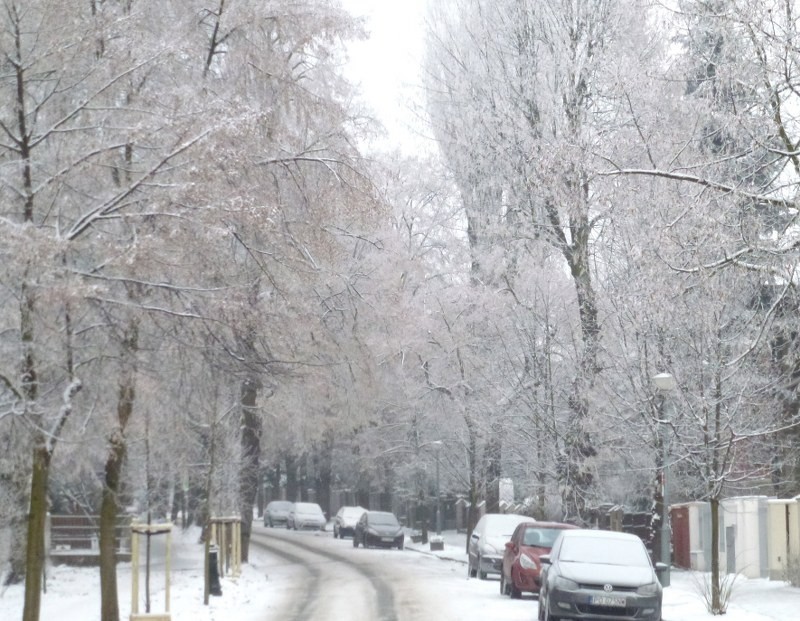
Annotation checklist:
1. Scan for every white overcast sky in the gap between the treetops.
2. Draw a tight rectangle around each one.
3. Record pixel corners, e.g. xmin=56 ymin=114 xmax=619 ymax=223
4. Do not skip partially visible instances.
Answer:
xmin=342 ymin=0 xmax=428 ymax=150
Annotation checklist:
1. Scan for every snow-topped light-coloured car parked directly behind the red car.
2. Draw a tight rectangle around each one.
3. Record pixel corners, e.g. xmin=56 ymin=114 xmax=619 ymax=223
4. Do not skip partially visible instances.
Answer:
xmin=467 ymin=513 xmax=534 ymax=580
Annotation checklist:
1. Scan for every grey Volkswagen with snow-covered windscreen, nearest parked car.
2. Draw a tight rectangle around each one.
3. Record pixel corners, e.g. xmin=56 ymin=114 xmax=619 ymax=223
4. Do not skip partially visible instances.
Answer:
xmin=539 ymin=529 xmax=666 ymax=621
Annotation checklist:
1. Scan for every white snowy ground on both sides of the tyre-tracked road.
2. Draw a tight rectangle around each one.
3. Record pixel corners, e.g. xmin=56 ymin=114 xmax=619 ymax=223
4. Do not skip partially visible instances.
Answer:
xmin=0 ymin=530 xmax=800 ymax=621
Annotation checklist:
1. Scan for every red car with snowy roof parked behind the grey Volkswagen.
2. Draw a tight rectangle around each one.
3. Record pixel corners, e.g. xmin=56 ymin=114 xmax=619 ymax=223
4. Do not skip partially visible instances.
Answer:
xmin=500 ymin=522 xmax=577 ymax=598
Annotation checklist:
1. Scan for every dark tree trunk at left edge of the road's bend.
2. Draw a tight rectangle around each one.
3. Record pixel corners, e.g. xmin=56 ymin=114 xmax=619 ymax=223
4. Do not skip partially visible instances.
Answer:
xmin=239 ymin=378 xmax=261 ymax=563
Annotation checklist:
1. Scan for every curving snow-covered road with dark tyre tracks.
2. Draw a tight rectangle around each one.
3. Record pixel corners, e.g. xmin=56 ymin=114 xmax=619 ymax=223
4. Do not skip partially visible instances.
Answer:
xmin=251 ymin=529 xmax=537 ymax=621
